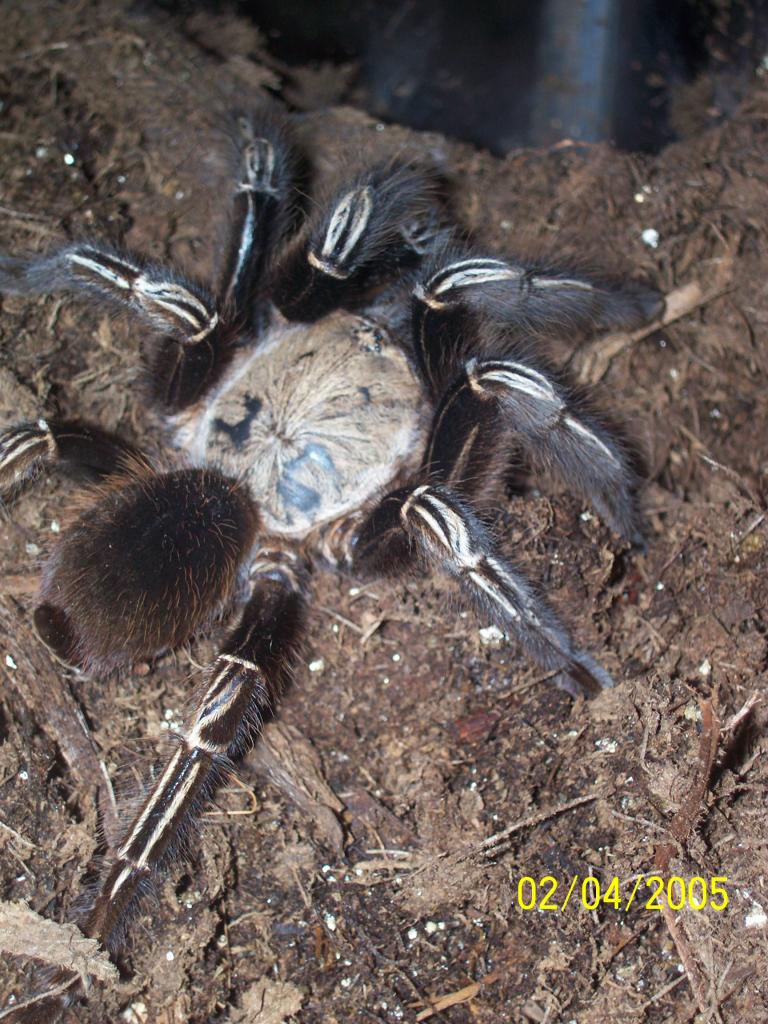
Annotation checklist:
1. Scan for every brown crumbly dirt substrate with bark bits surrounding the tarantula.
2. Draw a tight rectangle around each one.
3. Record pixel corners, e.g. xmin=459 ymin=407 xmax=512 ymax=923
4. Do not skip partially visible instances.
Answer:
xmin=0 ymin=2 xmax=768 ymax=1024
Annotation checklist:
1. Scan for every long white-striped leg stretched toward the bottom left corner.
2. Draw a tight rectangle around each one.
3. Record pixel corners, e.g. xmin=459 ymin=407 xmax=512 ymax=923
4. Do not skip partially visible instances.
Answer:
xmin=10 ymin=552 xmax=305 ymax=1024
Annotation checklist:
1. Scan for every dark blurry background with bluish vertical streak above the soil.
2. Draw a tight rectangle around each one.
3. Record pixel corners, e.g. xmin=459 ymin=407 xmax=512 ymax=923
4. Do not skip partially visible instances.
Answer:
xmin=156 ymin=0 xmax=768 ymax=155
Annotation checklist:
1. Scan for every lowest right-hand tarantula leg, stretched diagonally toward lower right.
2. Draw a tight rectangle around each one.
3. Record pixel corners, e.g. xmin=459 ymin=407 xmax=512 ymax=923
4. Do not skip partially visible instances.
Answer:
xmin=350 ymin=484 xmax=613 ymax=694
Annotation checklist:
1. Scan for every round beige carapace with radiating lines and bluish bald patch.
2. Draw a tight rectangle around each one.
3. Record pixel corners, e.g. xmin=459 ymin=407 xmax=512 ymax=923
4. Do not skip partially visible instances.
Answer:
xmin=177 ymin=313 xmax=423 ymax=538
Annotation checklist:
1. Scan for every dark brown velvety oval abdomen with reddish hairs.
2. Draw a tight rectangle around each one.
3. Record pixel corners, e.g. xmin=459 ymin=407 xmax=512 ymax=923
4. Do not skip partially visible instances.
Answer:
xmin=35 ymin=467 xmax=257 ymax=669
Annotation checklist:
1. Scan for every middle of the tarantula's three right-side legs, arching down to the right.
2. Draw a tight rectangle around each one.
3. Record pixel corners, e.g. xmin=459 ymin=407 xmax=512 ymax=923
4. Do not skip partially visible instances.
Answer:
xmin=424 ymin=356 xmax=643 ymax=545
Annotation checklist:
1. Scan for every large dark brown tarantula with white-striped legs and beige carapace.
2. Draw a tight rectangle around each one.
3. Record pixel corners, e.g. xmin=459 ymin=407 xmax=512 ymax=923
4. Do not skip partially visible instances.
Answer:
xmin=0 ymin=111 xmax=663 ymax=1022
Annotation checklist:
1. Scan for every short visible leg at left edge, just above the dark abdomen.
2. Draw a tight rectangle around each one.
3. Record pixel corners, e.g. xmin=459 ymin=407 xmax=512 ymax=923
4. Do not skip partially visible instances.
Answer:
xmin=0 ymin=420 xmax=142 ymax=500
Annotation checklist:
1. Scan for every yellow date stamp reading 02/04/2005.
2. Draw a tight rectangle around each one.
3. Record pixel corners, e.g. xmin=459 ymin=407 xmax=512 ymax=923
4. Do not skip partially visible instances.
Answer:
xmin=515 ymin=874 xmax=728 ymax=913
